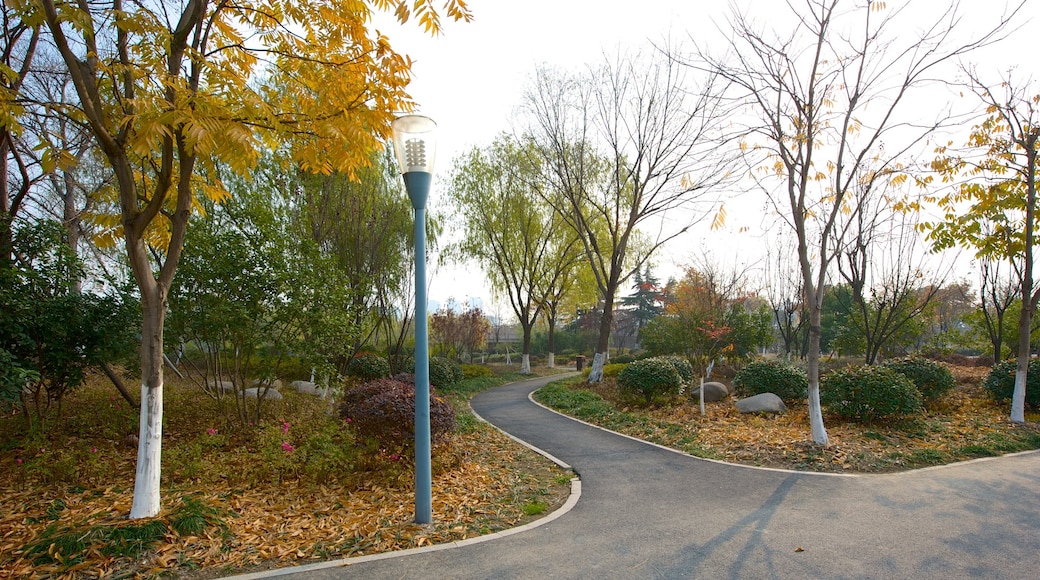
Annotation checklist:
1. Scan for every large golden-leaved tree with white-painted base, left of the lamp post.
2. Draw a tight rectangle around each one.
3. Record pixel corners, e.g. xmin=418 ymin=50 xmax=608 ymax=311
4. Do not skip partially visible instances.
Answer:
xmin=0 ymin=0 xmax=469 ymax=518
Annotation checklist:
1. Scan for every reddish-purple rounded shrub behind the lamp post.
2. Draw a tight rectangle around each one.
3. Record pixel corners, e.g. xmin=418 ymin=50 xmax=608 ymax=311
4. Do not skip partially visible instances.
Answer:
xmin=340 ymin=378 xmax=456 ymax=449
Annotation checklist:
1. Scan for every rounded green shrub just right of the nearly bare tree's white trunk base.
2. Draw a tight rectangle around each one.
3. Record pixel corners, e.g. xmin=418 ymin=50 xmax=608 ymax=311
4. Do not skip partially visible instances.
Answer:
xmin=820 ymin=366 xmax=924 ymax=422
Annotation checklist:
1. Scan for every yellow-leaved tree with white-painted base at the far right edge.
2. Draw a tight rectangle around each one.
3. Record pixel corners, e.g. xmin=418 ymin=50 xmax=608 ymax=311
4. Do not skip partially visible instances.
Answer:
xmin=929 ymin=71 xmax=1040 ymax=423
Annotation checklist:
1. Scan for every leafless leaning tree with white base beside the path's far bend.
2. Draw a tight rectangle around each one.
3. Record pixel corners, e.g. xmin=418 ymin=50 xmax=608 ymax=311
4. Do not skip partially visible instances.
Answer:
xmin=525 ymin=47 xmax=730 ymax=383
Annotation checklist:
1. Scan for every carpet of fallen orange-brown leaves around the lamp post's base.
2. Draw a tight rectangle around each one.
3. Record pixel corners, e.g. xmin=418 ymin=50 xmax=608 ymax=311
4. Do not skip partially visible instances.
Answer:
xmin=0 ymin=427 xmax=570 ymax=579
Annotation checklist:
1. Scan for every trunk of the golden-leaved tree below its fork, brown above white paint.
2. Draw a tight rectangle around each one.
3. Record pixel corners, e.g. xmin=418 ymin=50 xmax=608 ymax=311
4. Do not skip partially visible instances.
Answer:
xmin=130 ymin=288 xmax=166 ymax=520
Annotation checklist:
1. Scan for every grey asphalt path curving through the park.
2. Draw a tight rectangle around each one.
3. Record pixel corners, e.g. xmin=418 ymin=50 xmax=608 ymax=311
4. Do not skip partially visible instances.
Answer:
xmin=236 ymin=377 xmax=1040 ymax=579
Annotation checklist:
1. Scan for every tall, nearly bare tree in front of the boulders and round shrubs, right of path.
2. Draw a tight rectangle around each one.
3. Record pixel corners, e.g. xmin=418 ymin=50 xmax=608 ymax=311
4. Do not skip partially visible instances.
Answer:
xmin=694 ymin=0 xmax=1010 ymax=445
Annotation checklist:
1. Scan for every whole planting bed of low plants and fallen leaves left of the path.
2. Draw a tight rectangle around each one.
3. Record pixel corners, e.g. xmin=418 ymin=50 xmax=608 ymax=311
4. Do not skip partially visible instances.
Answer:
xmin=0 ymin=369 xmax=572 ymax=579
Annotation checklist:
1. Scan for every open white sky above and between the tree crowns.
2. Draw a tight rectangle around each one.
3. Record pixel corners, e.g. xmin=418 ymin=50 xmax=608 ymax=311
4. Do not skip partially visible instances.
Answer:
xmin=375 ymin=0 xmax=1040 ymax=312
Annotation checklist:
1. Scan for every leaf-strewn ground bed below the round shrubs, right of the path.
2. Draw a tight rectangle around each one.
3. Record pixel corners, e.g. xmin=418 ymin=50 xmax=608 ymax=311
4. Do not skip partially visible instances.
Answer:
xmin=536 ymin=367 xmax=1040 ymax=473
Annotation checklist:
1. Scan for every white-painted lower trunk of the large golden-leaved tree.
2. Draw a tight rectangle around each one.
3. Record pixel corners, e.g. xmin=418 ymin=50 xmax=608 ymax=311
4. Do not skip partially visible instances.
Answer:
xmin=130 ymin=381 xmax=162 ymax=520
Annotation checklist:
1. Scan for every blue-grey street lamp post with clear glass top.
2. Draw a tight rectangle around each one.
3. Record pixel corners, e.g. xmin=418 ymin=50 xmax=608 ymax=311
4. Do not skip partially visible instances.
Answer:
xmin=391 ymin=114 xmax=437 ymax=524
